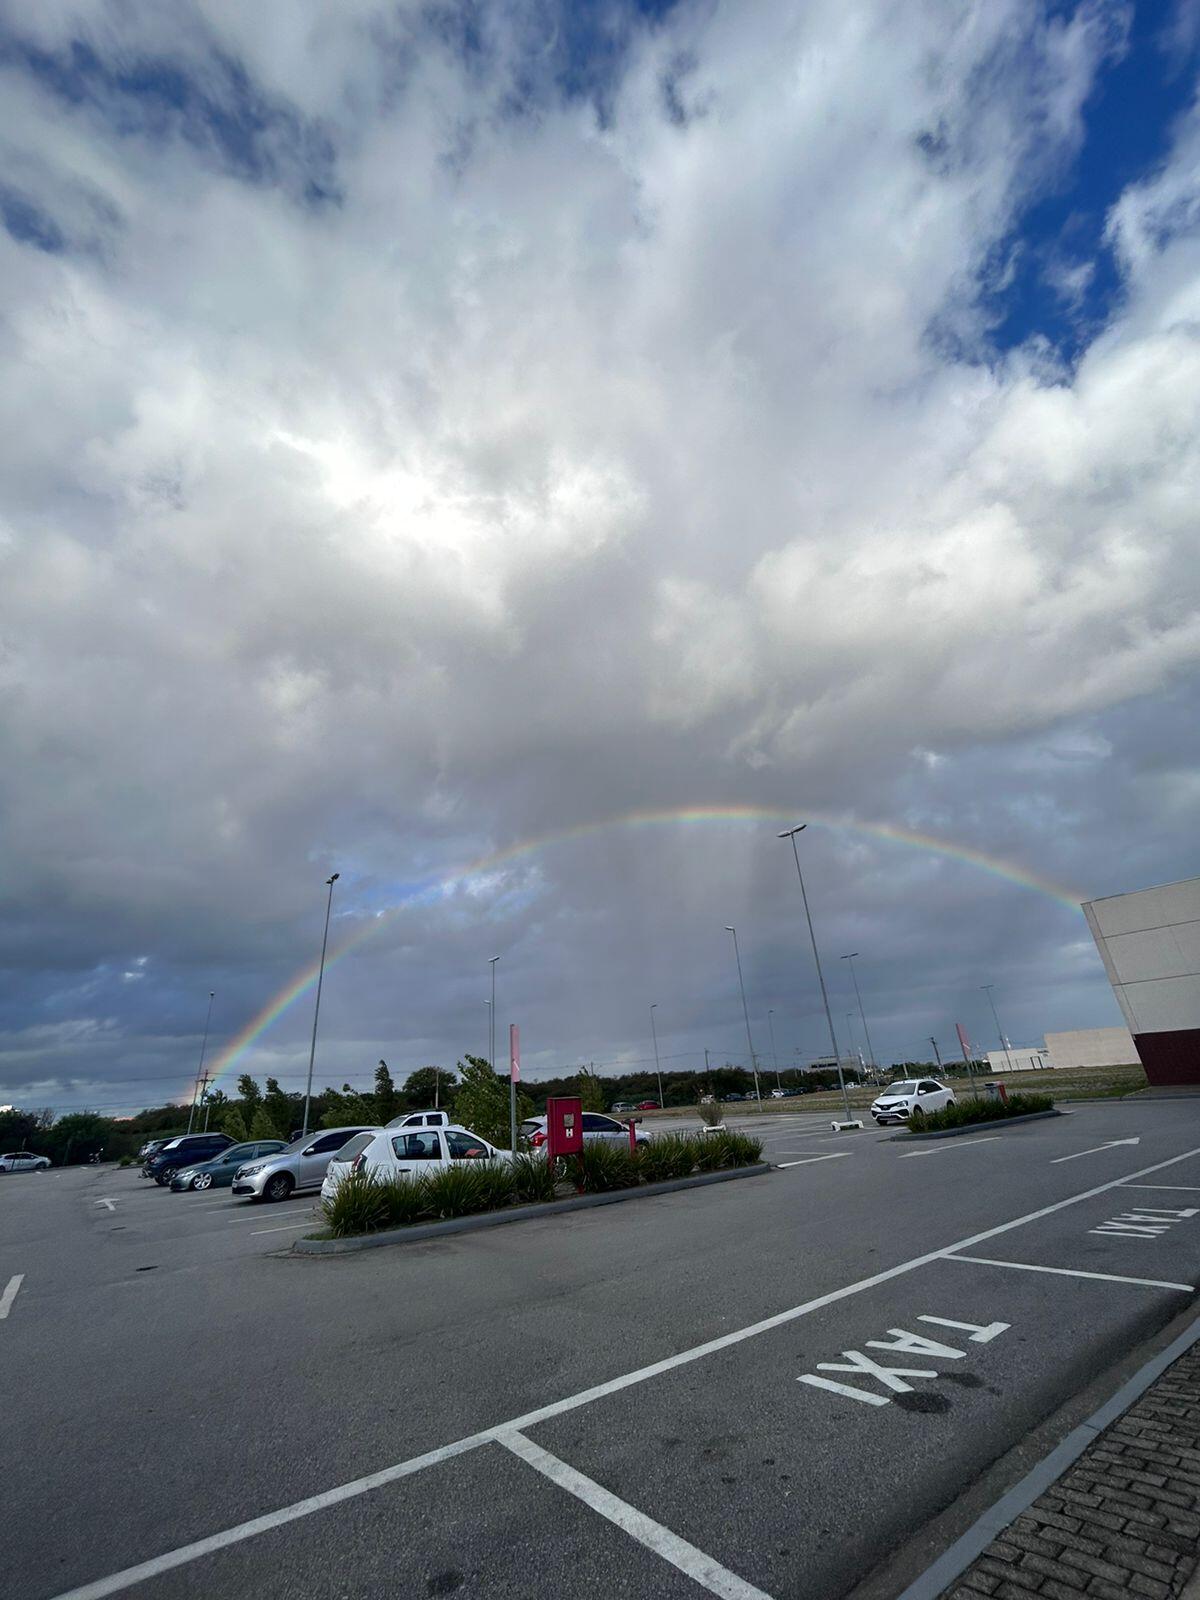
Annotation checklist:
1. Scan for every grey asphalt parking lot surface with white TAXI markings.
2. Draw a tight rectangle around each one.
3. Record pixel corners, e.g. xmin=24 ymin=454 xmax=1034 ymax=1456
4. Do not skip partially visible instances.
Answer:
xmin=0 ymin=1101 xmax=1200 ymax=1600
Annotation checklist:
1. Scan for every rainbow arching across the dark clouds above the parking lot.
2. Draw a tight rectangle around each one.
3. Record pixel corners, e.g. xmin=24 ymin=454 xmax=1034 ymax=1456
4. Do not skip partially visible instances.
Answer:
xmin=192 ymin=805 xmax=1083 ymax=1096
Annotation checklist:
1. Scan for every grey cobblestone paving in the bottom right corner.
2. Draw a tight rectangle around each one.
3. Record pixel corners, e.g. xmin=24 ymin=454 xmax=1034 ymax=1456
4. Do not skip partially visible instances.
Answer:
xmin=947 ymin=1346 xmax=1200 ymax=1600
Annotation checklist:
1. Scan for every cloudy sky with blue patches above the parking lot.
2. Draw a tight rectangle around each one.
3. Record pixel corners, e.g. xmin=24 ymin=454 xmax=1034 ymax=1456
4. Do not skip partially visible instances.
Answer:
xmin=0 ymin=0 xmax=1200 ymax=1110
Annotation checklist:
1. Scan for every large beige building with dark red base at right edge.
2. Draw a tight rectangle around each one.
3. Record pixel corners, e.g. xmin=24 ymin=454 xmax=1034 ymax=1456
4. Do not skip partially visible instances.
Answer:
xmin=1083 ymin=878 xmax=1200 ymax=1085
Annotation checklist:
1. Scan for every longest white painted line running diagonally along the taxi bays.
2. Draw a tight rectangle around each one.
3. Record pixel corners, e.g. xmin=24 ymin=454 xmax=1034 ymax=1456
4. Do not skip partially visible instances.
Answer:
xmin=42 ymin=1146 xmax=1200 ymax=1600
